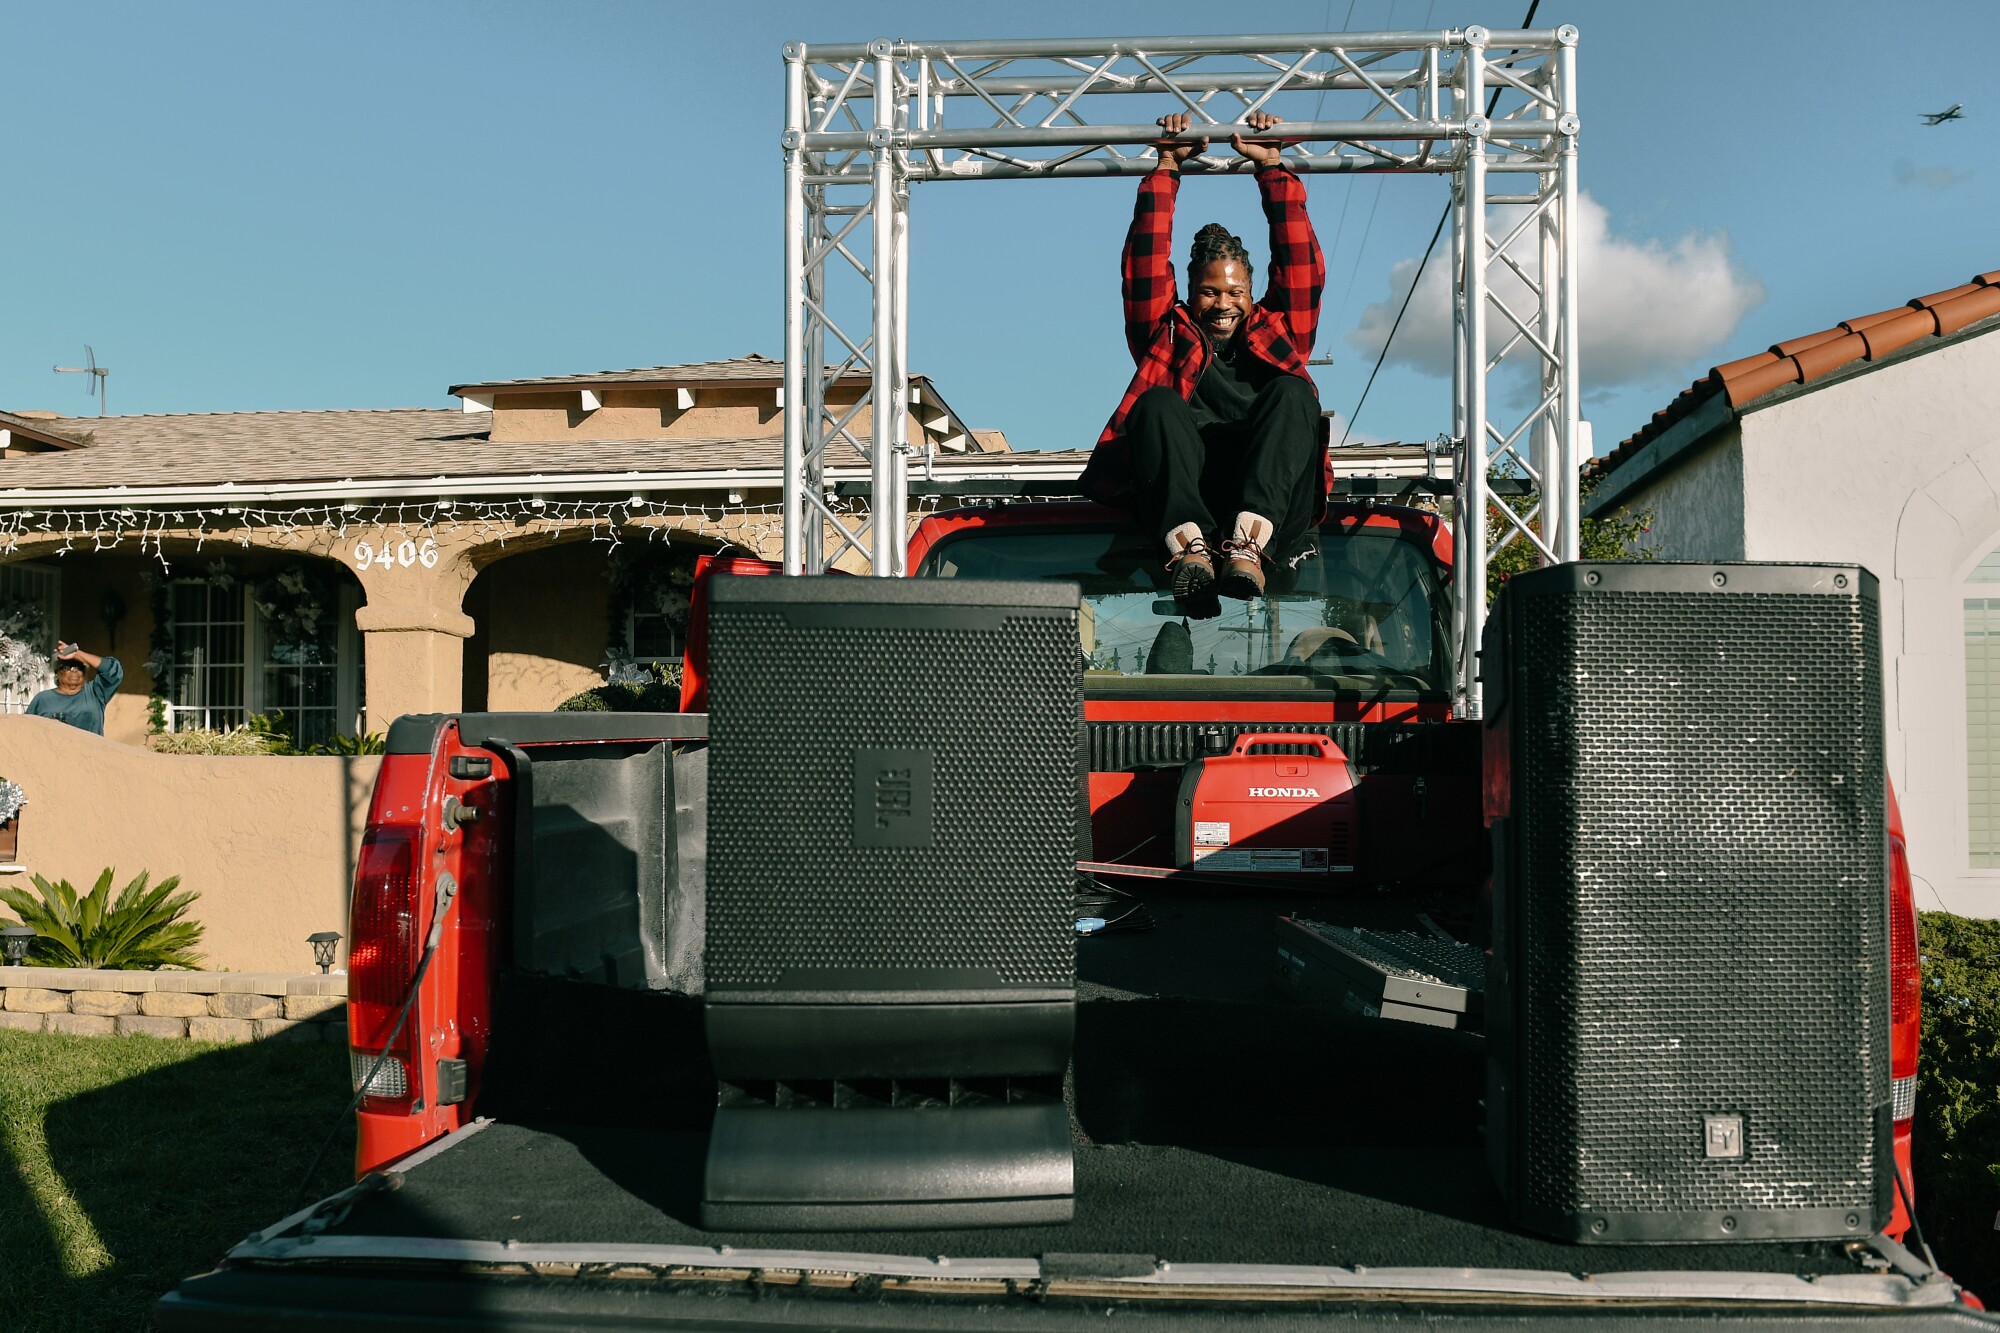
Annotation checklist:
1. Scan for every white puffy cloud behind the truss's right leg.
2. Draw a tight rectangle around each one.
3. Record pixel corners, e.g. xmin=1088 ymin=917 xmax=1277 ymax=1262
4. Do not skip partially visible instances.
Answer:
xmin=1348 ymin=194 xmax=1764 ymax=394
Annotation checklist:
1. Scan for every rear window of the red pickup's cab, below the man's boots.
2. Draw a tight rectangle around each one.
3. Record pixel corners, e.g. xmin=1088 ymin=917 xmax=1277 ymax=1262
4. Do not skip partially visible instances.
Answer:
xmin=916 ymin=526 xmax=1452 ymax=695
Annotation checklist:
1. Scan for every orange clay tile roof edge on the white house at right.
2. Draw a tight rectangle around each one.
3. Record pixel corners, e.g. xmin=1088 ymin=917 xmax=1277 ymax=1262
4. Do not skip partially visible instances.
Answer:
xmin=1584 ymin=268 xmax=2000 ymax=476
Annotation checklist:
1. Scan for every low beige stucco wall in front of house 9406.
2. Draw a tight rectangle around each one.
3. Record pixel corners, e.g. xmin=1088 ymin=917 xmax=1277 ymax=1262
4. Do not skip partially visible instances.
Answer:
xmin=0 ymin=716 xmax=382 ymax=971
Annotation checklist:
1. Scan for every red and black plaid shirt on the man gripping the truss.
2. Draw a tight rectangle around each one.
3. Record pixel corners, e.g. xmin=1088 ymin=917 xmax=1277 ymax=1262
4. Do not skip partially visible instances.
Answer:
xmin=1080 ymin=166 xmax=1334 ymax=518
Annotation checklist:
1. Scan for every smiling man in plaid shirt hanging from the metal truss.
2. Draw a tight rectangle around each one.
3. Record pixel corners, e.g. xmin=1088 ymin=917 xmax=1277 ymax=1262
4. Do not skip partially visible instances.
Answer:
xmin=1082 ymin=112 xmax=1332 ymax=618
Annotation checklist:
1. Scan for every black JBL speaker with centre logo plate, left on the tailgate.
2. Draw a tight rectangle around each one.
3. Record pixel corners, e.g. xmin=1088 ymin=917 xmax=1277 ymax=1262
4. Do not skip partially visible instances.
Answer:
xmin=702 ymin=576 xmax=1088 ymax=1229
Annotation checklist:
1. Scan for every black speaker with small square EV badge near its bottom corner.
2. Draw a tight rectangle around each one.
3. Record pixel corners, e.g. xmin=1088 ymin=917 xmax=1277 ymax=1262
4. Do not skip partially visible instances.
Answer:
xmin=1480 ymin=562 xmax=1894 ymax=1243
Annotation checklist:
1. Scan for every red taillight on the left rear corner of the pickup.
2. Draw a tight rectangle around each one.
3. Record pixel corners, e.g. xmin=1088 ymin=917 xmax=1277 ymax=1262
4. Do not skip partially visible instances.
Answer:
xmin=348 ymin=825 xmax=418 ymax=1111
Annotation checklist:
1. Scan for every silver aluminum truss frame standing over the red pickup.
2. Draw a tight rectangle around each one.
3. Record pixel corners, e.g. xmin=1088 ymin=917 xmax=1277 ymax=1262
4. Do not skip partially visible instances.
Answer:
xmin=784 ymin=26 xmax=1586 ymax=717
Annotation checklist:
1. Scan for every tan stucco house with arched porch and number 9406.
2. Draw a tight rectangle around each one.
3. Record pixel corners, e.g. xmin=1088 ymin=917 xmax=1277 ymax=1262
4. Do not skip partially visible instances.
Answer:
xmin=0 ymin=356 xmax=1082 ymax=745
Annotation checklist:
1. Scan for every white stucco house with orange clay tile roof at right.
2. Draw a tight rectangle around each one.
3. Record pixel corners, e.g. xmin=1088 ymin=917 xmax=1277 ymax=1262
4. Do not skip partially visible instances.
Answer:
xmin=1584 ymin=270 xmax=2000 ymax=917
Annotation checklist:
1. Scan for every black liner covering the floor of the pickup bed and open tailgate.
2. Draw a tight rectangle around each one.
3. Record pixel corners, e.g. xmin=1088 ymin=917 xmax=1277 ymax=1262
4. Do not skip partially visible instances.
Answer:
xmin=215 ymin=895 xmax=1952 ymax=1277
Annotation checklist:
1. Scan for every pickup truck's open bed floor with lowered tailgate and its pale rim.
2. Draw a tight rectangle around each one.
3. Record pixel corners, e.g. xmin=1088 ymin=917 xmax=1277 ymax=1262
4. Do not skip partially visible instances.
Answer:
xmin=172 ymin=891 xmax=1976 ymax=1329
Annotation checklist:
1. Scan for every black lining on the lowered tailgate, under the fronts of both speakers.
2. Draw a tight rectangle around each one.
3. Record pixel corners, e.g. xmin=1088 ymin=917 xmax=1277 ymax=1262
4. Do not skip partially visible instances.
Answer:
xmin=312 ymin=1123 xmax=1862 ymax=1275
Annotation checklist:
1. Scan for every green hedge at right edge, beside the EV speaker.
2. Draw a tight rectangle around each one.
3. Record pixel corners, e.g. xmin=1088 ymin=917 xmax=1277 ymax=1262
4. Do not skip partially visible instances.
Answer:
xmin=1910 ymin=913 xmax=2000 ymax=1299
